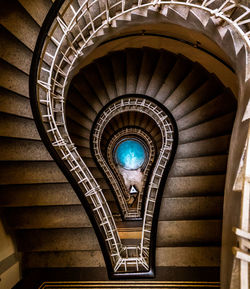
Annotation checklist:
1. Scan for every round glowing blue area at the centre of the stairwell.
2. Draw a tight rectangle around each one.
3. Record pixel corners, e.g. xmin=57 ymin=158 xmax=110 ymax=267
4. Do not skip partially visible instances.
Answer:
xmin=115 ymin=140 xmax=146 ymax=170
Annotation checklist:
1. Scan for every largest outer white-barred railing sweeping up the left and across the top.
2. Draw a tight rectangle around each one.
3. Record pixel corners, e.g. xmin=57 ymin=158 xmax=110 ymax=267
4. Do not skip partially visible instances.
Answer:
xmin=30 ymin=0 xmax=250 ymax=276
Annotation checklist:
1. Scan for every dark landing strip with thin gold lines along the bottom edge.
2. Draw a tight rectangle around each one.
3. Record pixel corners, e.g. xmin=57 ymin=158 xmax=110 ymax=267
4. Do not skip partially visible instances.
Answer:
xmin=15 ymin=266 xmax=220 ymax=282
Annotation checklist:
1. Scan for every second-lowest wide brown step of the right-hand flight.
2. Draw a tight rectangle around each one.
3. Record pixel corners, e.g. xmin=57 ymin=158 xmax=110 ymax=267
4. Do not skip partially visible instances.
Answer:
xmin=157 ymin=220 xmax=221 ymax=247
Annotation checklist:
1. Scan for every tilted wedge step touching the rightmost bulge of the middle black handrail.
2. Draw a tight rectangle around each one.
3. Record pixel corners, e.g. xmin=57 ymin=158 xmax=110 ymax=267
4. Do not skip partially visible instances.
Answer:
xmin=179 ymin=112 xmax=235 ymax=144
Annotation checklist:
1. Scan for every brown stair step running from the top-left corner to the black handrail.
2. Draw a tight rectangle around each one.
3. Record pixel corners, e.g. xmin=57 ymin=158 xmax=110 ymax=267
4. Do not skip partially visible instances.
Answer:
xmin=1 ymin=0 xmax=40 ymax=51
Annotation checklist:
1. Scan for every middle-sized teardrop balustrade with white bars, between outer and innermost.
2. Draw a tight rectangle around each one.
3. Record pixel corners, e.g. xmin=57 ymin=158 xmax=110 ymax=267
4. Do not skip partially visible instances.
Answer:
xmin=92 ymin=97 xmax=177 ymax=271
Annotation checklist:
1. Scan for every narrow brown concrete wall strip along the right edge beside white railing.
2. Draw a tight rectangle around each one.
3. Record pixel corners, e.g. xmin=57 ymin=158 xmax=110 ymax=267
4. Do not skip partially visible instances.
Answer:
xmin=221 ymin=80 xmax=250 ymax=289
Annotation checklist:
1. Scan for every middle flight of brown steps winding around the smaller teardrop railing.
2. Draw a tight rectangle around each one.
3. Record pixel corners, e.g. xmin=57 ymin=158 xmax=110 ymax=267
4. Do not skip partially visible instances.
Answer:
xmin=66 ymin=47 xmax=236 ymax=274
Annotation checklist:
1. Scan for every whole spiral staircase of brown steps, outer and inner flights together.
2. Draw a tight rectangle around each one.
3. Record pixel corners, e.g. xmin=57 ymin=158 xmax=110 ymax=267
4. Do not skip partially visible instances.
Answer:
xmin=0 ymin=0 xmax=249 ymax=288
